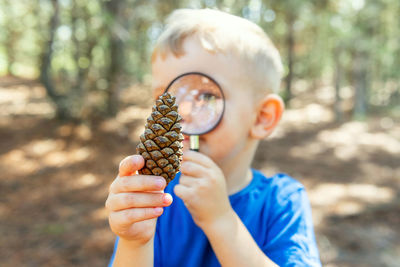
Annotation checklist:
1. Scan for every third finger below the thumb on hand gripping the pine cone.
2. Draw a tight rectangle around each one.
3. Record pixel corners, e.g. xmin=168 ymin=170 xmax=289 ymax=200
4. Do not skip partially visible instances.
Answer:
xmin=109 ymin=207 xmax=164 ymax=226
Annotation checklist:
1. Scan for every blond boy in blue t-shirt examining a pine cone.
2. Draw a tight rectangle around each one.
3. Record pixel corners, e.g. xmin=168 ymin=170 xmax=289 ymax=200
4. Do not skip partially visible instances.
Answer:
xmin=106 ymin=9 xmax=321 ymax=266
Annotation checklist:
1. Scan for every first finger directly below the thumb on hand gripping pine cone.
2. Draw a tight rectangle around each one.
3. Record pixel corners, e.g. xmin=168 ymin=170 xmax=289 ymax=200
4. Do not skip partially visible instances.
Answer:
xmin=110 ymin=175 xmax=167 ymax=193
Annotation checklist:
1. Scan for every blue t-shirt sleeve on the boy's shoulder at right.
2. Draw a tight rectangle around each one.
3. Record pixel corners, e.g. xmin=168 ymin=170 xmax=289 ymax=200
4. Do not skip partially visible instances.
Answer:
xmin=263 ymin=187 xmax=321 ymax=267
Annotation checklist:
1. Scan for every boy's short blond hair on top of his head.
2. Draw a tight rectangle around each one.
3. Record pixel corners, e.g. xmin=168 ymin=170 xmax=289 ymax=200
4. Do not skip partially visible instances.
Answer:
xmin=152 ymin=9 xmax=282 ymax=92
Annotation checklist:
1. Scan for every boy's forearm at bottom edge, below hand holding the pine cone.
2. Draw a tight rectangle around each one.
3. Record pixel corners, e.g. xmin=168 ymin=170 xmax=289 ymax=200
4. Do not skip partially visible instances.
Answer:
xmin=113 ymin=238 xmax=154 ymax=267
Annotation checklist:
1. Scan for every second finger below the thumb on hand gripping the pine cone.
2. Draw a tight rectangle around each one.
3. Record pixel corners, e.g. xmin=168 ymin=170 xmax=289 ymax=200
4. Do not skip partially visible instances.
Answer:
xmin=106 ymin=193 xmax=172 ymax=211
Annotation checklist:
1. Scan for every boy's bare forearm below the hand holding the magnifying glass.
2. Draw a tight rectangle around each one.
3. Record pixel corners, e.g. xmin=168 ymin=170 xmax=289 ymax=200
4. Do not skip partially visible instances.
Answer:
xmin=203 ymin=210 xmax=277 ymax=267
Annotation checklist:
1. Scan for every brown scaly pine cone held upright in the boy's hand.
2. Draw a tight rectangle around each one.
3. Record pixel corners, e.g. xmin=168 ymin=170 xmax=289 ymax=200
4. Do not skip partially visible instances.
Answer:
xmin=136 ymin=93 xmax=183 ymax=184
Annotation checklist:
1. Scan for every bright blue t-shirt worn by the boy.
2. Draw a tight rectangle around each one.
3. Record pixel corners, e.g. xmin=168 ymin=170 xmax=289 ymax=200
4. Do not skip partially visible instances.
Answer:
xmin=109 ymin=170 xmax=321 ymax=267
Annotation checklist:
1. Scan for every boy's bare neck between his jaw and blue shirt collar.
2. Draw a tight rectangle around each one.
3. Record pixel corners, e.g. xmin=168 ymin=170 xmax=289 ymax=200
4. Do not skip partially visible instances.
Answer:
xmin=221 ymin=140 xmax=257 ymax=195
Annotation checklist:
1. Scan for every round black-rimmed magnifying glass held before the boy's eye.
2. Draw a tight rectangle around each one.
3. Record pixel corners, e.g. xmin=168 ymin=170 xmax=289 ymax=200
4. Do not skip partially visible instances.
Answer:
xmin=165 ymin=72 xmax=225 ymax=151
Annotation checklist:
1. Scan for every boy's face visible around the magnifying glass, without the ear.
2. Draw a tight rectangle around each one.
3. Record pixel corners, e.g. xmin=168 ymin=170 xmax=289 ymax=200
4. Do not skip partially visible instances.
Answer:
xmin=152 ymin=37 xmax=256 ymax=165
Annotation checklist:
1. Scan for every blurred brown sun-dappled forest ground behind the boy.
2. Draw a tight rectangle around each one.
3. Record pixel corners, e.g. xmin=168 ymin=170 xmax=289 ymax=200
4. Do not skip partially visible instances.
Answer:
xmin=0 ymin=78 xmax=400 ymax=267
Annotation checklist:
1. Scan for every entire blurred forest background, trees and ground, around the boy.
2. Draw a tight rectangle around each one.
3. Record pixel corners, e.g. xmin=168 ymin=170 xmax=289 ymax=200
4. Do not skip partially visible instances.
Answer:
xmin=0 ymin=0 xmax=400 ymax=266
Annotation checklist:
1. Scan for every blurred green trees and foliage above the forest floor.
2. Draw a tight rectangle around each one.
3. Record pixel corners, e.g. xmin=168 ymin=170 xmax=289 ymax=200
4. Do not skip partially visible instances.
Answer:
xmin=0 ymin=0 xmax=400 ymax=119
